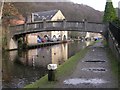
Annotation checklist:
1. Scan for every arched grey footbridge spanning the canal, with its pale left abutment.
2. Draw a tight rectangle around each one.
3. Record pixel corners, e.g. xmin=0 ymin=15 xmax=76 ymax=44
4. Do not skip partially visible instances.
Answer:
xmin=8 ymin=20 xmax=107 ymax=49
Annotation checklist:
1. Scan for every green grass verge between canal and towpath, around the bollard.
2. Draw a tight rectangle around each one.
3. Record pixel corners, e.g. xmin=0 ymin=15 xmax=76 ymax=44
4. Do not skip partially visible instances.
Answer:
xmin=25 ymin=48 xmax=88 ymax=88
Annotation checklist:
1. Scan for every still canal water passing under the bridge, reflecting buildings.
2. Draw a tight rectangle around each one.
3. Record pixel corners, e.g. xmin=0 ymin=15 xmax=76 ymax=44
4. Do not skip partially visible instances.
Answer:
xmin=2 ymin=41 xmax=90 ymax=88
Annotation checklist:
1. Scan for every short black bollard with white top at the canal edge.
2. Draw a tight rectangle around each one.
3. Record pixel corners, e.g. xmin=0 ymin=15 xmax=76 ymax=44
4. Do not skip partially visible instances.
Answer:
xmin=47 ymin=64 xmax=57 ymax=81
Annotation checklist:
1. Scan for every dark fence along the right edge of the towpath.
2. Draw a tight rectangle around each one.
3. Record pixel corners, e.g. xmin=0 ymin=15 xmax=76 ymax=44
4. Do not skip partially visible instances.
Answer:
xmin=108 ymin=23 xmax=120 ymax=61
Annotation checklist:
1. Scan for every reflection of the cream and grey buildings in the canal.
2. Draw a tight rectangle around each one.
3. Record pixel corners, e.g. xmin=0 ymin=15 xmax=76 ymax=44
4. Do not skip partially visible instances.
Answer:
xmin=13 ymin=43 xmax=68 ymax=67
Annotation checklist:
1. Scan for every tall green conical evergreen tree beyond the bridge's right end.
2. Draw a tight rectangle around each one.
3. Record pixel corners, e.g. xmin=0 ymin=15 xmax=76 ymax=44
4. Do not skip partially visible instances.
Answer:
xmin=103 ymin=0 xmax=117 ymax=22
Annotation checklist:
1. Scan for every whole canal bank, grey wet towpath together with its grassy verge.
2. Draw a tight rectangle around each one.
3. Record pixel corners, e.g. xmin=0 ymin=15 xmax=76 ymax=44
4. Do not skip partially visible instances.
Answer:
xmin=25 ymin=42 xmax=118 ymax=88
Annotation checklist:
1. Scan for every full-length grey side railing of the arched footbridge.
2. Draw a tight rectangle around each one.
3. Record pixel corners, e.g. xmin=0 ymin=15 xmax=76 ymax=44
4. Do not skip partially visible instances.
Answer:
xmin=10 ymin=20 xmax=105 ymax=36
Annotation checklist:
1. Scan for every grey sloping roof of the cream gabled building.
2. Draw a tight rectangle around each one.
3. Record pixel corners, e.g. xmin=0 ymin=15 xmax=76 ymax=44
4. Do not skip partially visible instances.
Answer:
xmin=32 ymin=10 xmax=58 ymax=21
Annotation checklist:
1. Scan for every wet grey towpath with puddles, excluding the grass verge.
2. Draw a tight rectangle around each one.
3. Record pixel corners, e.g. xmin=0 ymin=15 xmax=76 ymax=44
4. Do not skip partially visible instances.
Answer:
xmin=57 ymin=42 xmax=118 ymax=88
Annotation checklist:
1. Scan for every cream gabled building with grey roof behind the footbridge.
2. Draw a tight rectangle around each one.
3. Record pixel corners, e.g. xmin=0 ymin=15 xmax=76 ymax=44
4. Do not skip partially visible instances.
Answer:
xmin=27 ymin=10 xmax=68 ymax=43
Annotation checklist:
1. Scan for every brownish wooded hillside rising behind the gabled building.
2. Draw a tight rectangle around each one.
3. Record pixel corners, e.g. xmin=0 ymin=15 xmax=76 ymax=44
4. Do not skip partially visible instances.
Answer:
xmin=13 ymin=2 xmax=103 ymax=22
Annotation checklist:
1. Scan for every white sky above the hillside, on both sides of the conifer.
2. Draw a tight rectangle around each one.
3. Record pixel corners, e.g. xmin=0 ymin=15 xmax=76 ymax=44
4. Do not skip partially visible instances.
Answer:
xmin=71 ymin=0 xmax=120 ymax=11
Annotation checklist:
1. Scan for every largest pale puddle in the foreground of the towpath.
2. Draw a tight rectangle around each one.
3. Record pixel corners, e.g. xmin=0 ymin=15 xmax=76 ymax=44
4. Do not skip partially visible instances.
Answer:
xmin=63 ymin=78 xmax=108 ymax=85
